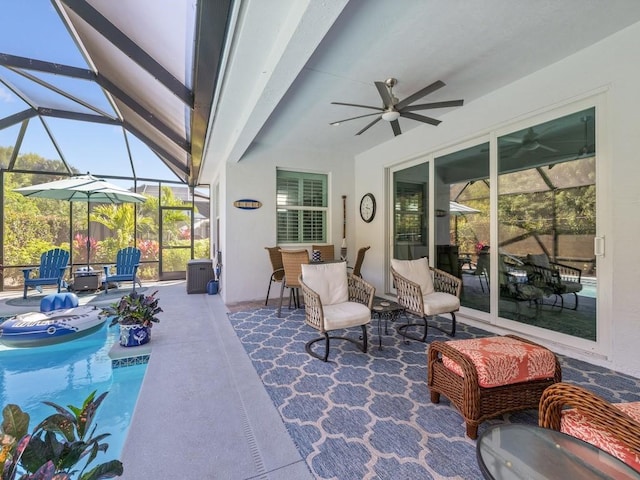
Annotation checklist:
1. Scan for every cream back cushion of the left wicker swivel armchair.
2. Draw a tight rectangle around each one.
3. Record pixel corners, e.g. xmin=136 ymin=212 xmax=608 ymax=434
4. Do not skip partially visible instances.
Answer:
xmin=302 ymin=262 xmax=349 ymax=308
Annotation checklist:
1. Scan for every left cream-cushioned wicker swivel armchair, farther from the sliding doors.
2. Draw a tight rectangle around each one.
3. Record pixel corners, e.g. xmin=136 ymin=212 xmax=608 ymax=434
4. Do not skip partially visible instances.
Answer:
xmin=298 ymin=262 xmax=375 ymax=362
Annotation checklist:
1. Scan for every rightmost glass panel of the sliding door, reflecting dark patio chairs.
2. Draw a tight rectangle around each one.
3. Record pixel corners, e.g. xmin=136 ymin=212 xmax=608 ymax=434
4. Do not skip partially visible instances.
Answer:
xmin=497 ymin=108 xmax=597 ymax=341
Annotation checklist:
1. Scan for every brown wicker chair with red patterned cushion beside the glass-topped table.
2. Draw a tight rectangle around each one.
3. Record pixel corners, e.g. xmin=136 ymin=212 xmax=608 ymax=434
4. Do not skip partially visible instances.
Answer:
xmin=538 ymin=382 xmax=640 ymax=470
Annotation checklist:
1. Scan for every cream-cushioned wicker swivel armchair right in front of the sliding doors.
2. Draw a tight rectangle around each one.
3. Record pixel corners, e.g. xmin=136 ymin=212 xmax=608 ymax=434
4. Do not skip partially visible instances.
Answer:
xmin=391 ymin=258 xmax=462 ymax=342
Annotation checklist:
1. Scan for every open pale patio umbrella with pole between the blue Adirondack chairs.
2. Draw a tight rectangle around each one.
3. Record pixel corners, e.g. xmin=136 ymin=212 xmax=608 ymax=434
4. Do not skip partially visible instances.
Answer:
xmin=15 ymin=173 xmax=146 ymax=267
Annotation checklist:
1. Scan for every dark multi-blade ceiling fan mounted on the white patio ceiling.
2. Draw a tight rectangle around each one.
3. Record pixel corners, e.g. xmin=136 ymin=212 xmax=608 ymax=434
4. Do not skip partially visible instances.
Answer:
xmin=330 ymin=78 xmax=464 ymax=136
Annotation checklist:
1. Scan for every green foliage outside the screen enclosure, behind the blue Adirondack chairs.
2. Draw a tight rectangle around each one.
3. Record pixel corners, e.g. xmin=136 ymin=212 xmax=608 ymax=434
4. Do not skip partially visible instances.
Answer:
xmin=0 ymin=147 xmax=209 ymax=285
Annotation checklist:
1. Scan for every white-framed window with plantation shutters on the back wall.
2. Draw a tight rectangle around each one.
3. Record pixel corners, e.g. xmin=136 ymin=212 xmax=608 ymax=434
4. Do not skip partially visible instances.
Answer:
xmin=276 ymin=170 xmax=328 ymax=243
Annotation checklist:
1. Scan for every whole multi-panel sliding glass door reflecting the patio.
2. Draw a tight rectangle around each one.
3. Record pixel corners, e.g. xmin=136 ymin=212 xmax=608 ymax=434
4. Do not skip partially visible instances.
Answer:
xmin=393 ymin=108 xmax=598 ymax=341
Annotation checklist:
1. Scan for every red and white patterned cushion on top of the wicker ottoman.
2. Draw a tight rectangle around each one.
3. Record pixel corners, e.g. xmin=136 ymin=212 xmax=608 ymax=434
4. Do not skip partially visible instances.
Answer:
xmin=442 ymin=336 xmax=556 ymax=388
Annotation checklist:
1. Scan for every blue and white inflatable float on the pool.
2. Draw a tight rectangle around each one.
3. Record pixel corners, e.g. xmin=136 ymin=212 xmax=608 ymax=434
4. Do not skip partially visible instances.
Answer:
xmin=0 ymin=294 xmax=107 ymax=347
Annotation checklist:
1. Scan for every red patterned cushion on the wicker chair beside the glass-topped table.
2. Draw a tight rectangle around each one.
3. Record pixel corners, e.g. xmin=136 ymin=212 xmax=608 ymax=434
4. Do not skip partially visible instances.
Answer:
xmin=560 ymin=402 xmax=640 ymax=471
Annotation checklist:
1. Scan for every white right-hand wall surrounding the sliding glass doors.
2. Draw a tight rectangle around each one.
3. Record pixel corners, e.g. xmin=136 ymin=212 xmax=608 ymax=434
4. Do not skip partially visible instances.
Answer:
xmin=355 ymin=24 xmax=640 ymax=377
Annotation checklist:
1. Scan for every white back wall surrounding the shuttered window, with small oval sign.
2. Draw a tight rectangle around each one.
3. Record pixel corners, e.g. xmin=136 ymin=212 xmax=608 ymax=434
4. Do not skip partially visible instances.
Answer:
xmin=221 ymin=142 xmax=359 ymax=304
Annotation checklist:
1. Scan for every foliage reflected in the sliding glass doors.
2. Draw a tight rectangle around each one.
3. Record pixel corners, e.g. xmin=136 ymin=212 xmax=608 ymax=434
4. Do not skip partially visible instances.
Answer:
xmin=450 ymin=157 xmax=596 ymax=267
